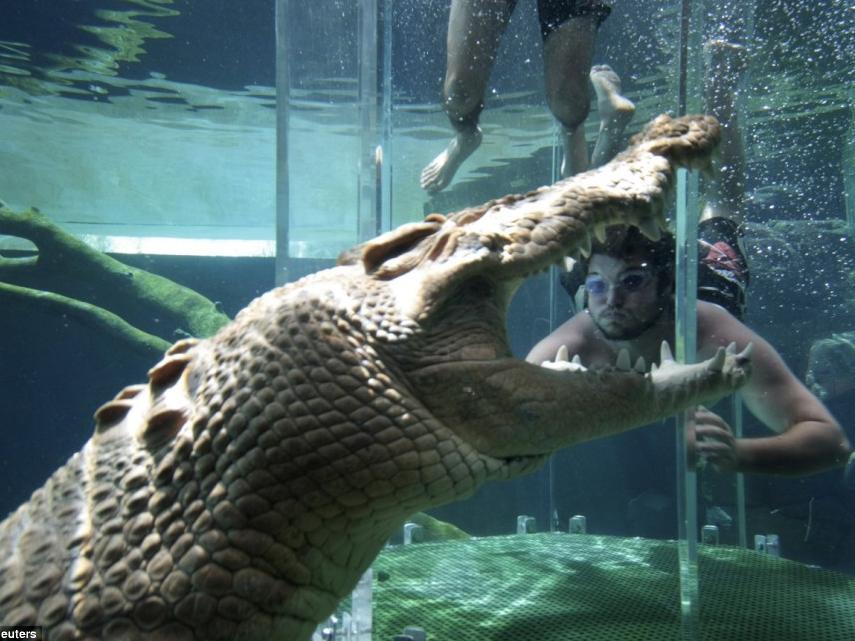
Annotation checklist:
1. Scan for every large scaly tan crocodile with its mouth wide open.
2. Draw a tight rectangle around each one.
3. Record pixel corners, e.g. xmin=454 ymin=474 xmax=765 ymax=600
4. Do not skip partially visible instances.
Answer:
xmin=0 ymin=116 xmax=750 ymax=641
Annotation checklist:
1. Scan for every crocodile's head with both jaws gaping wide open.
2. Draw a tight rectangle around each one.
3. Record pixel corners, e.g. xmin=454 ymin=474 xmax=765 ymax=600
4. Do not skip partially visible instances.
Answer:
xmin=340 ymin=111 xmax=745 ymax=464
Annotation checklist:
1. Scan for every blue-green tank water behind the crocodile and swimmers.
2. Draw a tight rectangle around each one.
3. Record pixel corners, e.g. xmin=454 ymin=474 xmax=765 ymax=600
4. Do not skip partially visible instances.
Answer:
xmin=0 ymin=0 xmax=855 ymax=638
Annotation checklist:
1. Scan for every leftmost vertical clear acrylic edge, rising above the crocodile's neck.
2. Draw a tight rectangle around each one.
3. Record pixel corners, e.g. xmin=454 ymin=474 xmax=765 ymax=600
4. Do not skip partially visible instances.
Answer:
xmin=274 ymin=0 xmax=291 ymax=285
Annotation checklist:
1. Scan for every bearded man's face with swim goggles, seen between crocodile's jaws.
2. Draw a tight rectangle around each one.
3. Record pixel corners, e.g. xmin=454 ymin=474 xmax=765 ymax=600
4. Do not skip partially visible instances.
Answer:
xmin=585 ymin=254 xmax=667 ymax=340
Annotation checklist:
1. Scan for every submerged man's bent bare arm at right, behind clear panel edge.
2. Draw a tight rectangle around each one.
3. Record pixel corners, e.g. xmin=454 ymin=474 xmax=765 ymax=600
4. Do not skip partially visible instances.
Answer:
xmin=695 ymin=309 xmax=852 ymax=476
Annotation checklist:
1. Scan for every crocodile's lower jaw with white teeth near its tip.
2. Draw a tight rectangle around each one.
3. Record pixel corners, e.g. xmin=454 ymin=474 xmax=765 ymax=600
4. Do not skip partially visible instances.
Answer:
xmin=408 ymin=348 xmax=750 ymax=465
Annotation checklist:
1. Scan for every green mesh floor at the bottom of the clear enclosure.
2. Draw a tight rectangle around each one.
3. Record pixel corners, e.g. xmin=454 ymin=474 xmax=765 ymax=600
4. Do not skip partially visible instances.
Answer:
xmin=373 ymin=534 xmax=855 ymax=641
